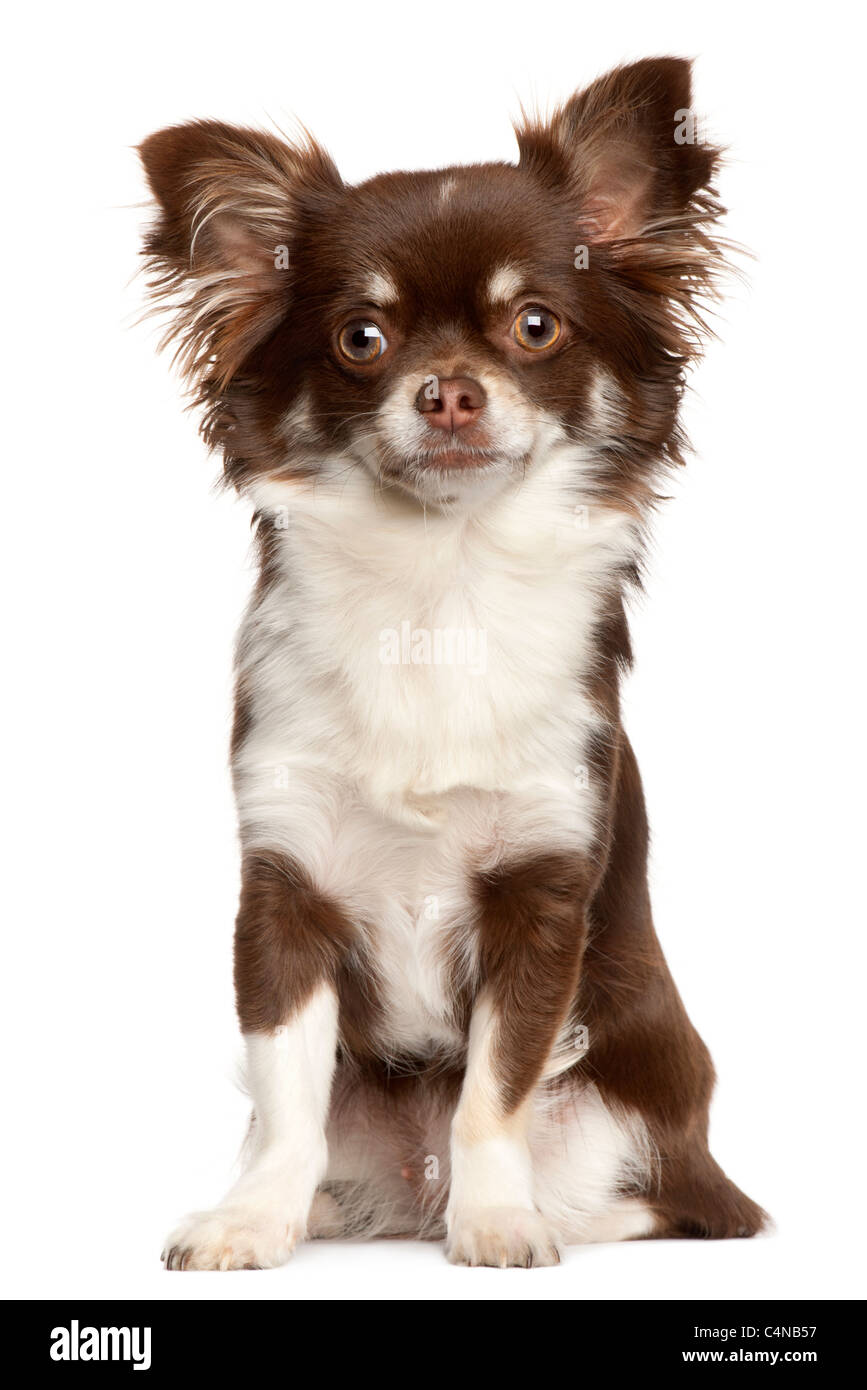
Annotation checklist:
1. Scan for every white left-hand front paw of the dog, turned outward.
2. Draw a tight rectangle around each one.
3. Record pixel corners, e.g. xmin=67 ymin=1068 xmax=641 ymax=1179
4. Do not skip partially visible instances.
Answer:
xmin=161 ymin=1207 xmax=303 ymax=1269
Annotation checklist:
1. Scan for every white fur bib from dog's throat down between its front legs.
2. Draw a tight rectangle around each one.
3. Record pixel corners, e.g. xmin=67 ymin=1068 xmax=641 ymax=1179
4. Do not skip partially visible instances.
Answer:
xmin=235 ymin=450 xmax=635 ymax=1049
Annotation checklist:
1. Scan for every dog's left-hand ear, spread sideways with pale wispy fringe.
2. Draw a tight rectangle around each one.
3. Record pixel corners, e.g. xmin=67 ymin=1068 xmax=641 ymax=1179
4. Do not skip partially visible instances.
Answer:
xmin=139 ymin=121 xmax=342 ymax=389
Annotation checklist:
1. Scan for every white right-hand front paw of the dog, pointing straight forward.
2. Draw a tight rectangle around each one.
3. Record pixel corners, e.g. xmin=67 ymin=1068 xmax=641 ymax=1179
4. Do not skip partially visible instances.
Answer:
xmin=446 ymin=1207 xmax=560 ymax=1269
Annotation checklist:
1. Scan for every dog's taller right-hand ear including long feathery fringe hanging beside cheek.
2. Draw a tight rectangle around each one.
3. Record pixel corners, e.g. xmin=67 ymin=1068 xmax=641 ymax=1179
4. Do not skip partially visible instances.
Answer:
xmin=517 ymin=58 xmax=734 ymax=450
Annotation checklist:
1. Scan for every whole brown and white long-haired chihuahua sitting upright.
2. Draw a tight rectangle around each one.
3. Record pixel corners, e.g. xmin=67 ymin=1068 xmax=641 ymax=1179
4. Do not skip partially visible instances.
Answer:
xmin=140 ymin=58 xmax=764 ymax=1269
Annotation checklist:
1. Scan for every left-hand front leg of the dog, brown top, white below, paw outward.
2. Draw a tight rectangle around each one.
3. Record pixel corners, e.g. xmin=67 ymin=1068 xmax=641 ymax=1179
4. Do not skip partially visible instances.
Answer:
xmin=164 ymin=855 xmax=345 ymax=1269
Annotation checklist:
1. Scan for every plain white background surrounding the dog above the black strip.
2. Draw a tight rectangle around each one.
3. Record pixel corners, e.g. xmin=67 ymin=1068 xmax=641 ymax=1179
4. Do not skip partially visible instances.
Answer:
xmin=0 ymin=0 xmax=866 ymax=1300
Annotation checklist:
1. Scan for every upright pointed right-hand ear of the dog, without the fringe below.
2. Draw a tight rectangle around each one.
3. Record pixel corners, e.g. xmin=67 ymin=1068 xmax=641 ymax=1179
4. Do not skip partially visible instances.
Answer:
xmin=517 ymin=58 xmax=718 ymax=243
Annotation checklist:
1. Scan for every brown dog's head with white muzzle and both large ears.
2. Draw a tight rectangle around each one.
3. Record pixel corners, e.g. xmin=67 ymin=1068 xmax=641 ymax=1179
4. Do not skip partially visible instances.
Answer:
xmin=140 ymin=58 xmax=720 ymax=506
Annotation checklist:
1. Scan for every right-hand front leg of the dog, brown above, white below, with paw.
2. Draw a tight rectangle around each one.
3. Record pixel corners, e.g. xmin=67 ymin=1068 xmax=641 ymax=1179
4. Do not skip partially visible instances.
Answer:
xmin=446 ymin=855 xmax=586 ymax=1266
